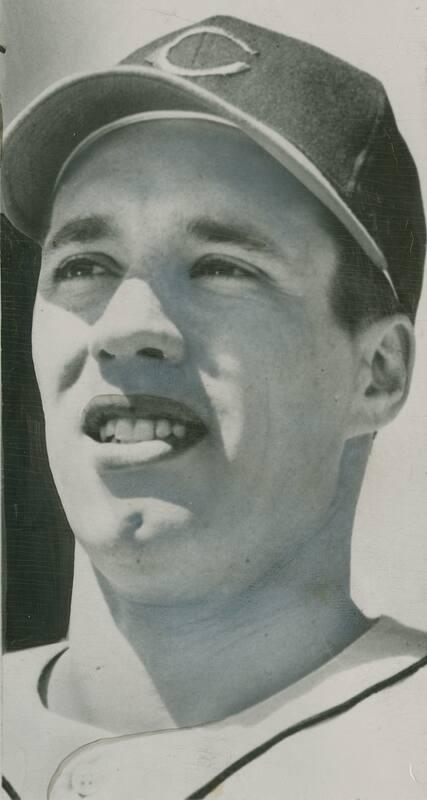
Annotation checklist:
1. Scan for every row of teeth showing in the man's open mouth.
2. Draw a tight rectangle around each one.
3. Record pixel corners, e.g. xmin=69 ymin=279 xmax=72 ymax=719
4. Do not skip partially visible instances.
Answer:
xmin=99 ymin=417 xmax=187 ymax=443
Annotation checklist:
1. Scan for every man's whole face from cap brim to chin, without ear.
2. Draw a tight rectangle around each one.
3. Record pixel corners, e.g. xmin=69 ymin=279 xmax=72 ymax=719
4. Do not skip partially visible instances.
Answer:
xmin=33 ymin=120 xmax=362 ymax=603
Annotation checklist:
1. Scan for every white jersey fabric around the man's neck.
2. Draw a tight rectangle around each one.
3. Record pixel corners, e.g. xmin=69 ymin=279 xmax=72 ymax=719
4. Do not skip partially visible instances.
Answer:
xmin=4 ymin=618 xmax=427 ymax=800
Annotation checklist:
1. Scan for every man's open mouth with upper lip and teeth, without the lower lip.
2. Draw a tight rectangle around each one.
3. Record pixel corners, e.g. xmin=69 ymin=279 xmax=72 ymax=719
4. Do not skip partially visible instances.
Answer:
xmin=82 ymin=395 xmax=207 ymax=451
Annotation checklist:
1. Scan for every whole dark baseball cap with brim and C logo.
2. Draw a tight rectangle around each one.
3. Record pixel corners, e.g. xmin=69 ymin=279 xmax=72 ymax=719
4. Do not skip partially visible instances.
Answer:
xmin=2 ymin=16 xmax=426 ymax=317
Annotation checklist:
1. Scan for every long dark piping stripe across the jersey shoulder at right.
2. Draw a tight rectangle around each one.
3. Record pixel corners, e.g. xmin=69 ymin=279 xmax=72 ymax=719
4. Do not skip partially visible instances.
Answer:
xmin=186 ymin=656 xmax=427 ymax=800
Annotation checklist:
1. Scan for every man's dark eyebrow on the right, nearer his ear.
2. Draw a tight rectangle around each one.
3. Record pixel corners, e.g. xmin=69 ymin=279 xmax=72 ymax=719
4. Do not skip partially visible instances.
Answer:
xmin=187 ymin=217 xmax=283 ymax=257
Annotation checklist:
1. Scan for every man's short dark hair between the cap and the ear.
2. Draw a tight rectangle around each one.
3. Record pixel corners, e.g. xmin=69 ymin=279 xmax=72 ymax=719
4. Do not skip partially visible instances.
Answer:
xmin=330 ymin=223 xmax=404 ymax=335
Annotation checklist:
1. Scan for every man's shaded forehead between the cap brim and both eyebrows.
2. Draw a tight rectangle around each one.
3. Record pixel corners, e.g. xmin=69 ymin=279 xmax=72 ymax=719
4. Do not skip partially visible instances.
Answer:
xmin=47 ymin=120 xmax=342 ymax=282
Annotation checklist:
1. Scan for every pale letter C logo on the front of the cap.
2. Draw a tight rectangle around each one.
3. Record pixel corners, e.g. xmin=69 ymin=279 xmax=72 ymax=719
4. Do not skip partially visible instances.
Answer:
xmin=145 ymin=25 xmax=258 ymax=78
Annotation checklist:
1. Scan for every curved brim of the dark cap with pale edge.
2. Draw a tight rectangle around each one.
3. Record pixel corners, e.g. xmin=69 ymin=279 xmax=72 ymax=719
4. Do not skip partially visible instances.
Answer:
xmin=2 ymin=66 xmax=387 ymax=275
